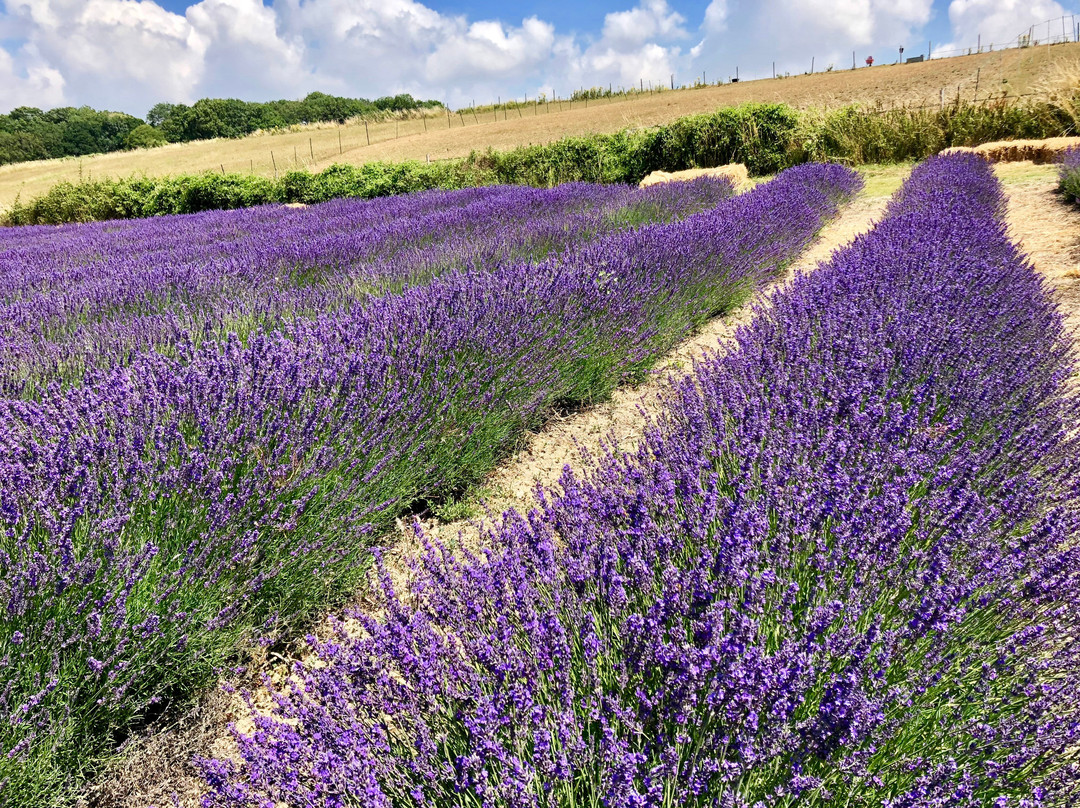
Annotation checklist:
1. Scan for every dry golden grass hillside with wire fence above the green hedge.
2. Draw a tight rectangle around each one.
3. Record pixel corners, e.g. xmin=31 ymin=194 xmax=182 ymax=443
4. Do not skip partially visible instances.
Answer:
xmin=0 ymin=43 xmax=1080 ymax=208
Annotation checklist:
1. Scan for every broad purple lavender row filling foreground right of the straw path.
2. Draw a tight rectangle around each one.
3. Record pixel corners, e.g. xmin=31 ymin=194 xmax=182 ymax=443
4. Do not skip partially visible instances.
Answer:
xmin=204 ymin=157 xmax=1080 ymax=808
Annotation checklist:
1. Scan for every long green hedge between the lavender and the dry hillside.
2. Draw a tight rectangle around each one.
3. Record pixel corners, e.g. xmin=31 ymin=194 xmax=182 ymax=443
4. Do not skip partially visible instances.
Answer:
xmin=2 ymin=99 xmax=1077 ymax=225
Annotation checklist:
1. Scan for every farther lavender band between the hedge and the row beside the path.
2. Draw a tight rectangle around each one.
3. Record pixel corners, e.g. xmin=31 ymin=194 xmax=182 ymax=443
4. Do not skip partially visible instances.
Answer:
xmin=0 ymin=181 xmax=732 ymax=398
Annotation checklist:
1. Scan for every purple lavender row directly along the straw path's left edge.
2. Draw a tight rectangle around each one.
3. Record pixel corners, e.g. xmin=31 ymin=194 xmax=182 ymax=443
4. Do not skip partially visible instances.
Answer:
xmin=0 ymin=166 xmax=860 ymax=804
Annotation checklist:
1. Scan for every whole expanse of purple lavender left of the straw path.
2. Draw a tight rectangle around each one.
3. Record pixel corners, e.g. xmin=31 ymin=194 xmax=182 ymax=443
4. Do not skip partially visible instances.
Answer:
xmin=0 ymin=165 xmax=860 ymax=806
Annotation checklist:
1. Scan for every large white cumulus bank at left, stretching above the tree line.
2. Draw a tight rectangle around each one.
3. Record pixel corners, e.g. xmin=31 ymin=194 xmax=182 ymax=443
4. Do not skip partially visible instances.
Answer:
xmin=0 ymin=0 xmax=689 ymax=113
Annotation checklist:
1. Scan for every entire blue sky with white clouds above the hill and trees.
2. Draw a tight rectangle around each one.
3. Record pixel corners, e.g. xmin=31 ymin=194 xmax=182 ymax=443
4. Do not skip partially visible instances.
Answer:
xmin=0 ymin=0 xmax=1080 ymax=117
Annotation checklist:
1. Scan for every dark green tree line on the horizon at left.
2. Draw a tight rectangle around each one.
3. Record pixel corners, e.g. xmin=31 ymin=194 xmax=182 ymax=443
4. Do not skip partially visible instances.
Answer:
xmin=0 ymin=93 xmax=443 ymax=165
